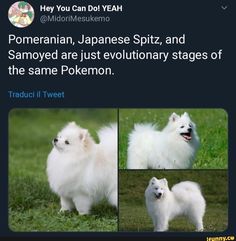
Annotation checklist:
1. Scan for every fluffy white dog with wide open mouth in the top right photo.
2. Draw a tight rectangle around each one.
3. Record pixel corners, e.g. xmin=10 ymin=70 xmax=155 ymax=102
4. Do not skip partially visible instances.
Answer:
xmin=127 ymin=112 xmax=199 ymax=169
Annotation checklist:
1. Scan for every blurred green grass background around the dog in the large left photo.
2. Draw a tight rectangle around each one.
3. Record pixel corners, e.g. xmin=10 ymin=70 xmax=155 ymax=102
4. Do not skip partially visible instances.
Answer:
xmin=9 ymin=109 xmax=117 ymax=232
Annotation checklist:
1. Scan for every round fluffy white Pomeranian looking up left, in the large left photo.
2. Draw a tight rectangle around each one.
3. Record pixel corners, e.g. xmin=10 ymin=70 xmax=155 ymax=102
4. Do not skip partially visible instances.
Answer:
xmin=47 ymin=122 xmax=117 ymax=215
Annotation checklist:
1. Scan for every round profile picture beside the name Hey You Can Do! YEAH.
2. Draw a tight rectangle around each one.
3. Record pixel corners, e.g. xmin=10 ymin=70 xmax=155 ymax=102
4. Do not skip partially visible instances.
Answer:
xmin=8 ymin=1 xmax=34 ymax=28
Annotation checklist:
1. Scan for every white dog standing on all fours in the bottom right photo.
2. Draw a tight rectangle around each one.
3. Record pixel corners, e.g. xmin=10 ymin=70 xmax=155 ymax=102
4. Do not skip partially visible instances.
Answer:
xmin=145 ymin=177 xmax=206 ymax=231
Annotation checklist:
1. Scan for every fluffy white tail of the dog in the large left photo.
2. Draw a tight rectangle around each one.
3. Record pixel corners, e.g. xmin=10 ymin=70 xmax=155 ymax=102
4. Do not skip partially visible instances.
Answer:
xmin=98 ymin=123 xmax=118 ymax=162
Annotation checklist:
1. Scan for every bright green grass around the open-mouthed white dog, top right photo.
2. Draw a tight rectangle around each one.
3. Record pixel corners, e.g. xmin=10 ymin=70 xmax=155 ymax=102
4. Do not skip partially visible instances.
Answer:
xmin=119 ymin=109 xmax=228 ymax=169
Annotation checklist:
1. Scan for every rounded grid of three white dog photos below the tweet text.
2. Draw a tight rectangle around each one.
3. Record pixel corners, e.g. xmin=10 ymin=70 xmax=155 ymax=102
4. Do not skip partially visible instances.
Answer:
xmin=8 ymin=108 xmax=228 ymax=232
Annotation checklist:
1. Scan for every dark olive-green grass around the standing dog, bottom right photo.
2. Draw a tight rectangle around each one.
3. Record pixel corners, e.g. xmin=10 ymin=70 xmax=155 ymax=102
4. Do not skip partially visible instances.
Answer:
xmin=119 ymin=170 xmax=228 ymax=232
